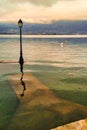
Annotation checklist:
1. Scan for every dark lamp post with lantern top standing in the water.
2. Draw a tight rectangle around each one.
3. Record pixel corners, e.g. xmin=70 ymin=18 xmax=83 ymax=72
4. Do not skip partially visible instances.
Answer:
xmin=18 ymin=19 xmax=24 ymax=75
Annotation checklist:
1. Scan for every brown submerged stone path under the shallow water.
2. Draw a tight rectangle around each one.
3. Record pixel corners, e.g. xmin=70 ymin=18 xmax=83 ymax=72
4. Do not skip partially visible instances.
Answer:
xmin=7 ymin=74 xmax=87 ymax=130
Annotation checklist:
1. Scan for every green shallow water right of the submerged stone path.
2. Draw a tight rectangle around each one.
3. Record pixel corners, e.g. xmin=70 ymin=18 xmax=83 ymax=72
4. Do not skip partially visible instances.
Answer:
xmin=29 ymin=65 xmax=87 ymax=106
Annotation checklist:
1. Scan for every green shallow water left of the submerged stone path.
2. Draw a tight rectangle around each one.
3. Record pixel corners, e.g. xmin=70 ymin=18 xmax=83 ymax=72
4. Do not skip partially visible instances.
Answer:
xmin=0 ymin=64 xmax=19 ymax=130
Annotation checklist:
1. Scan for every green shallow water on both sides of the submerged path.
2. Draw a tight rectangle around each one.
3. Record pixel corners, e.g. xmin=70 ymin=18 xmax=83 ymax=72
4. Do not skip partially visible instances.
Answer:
xmin=0 ymin=63 xmax=87 ymax=130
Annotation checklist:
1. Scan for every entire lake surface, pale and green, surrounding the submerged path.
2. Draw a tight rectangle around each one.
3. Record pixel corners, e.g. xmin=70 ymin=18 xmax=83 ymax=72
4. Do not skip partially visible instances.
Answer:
xmin=0 ymin=35 xmax=87 ymax=129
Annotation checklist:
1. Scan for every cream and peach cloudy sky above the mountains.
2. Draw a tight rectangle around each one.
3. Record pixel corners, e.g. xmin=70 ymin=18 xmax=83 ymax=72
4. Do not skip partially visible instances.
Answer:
xmin=0 ymin=0 xmax=87 ymax=23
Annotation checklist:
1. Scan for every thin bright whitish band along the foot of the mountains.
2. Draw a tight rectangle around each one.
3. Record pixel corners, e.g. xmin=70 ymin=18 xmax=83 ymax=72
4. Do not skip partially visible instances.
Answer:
xmin=0 ymin=34 xmax=87 ymax=38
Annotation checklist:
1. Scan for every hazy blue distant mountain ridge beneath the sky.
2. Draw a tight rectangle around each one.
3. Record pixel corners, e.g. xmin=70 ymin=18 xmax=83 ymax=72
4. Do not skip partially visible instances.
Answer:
xmin=0 ymin=20 xmax=87 ymax=35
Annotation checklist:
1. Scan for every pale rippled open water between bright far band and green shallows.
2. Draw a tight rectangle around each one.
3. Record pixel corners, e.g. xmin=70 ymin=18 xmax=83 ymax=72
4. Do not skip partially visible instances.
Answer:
xmin=0 ymin=35 xmax=87 ymax=67
